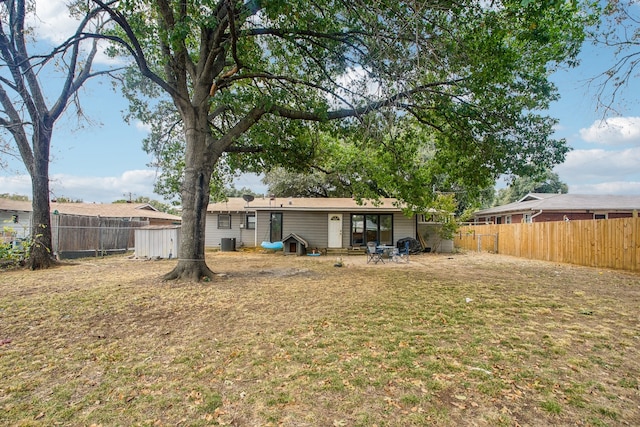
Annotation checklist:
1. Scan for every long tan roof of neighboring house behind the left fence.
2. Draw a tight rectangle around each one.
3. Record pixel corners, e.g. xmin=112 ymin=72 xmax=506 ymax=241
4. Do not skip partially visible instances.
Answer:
xmin=0 ymin=198 xmax=181 ymax=221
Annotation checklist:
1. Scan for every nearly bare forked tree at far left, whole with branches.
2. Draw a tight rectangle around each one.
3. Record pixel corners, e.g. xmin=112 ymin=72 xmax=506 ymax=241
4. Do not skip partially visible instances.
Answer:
xmin=0 ymin=0 xmax=115 ymax=269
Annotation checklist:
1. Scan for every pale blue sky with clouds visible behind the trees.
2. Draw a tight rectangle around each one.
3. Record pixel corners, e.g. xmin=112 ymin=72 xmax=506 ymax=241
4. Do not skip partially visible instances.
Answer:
xmin=0 ymin=1 xmax=640 ymax=203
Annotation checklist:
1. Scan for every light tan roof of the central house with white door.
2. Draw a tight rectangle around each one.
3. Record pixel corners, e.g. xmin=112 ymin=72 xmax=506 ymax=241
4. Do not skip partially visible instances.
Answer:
xmin=207 ymin=197 xmax=401 ymax=212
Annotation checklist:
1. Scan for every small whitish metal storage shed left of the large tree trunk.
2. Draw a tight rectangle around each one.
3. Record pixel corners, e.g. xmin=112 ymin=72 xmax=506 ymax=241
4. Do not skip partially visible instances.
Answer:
xmin=135 ymin=225 xmax=180 ymax=259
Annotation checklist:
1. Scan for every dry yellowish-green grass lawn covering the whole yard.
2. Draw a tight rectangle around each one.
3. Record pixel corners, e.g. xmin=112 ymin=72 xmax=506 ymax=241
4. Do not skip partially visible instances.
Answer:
xmin=0 ymin=252 xmax=640 ymax=427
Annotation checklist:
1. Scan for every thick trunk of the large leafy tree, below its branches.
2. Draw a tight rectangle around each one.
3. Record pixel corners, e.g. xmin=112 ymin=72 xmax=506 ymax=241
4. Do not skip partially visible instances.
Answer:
xmin=163 ymin=108 xmax=215 ymax=281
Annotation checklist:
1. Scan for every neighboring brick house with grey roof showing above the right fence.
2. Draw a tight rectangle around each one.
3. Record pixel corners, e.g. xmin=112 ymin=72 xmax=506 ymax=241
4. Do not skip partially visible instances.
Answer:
xmin=473 ymin=193 xmax=640 ymax=224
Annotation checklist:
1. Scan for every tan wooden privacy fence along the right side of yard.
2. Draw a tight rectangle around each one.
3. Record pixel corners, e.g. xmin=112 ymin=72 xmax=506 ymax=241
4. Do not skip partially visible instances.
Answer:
xmin=454 ymin=218 xmax=640 ymax=271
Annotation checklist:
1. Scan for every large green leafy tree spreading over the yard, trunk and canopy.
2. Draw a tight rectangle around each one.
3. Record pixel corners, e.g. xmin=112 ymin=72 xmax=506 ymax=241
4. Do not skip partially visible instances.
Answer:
xmin=93 ymin=0 xmax=586 ymax=280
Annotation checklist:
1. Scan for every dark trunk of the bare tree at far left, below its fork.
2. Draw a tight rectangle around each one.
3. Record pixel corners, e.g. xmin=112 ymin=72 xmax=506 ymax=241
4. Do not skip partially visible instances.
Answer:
xmin=28 ymin=132 xmax=54 ymax=270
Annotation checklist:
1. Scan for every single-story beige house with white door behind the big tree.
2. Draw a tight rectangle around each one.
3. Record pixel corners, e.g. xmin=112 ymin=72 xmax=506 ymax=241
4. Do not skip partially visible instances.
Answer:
xmin=205 ymin=197 xmax=453 ymax=252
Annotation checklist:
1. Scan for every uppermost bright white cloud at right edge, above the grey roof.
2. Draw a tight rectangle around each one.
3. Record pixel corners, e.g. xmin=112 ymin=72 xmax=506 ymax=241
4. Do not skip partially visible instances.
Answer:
xmin=580 ymin=117 xmax=640 ymax=145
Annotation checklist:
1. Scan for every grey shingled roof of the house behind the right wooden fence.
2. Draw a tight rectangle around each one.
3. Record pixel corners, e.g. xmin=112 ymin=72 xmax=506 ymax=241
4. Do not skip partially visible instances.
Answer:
xmin=474 ymin=193 xmax=640 ymax=217
